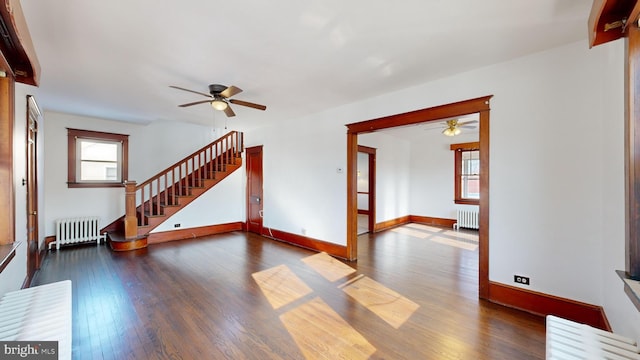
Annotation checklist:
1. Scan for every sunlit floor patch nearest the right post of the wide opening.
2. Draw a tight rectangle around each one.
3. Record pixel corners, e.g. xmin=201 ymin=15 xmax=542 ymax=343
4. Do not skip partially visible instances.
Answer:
xmin=340 ymin=276 xmax=420 ymax=329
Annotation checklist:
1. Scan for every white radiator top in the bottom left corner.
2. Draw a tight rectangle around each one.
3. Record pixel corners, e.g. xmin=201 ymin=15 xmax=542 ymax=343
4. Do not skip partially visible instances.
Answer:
xmin=0 ymin=280 xmax=72 ymax=360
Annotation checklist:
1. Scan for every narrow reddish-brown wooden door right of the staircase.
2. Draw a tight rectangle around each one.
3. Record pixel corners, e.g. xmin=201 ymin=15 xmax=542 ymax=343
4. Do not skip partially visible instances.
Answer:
xmin=246 ymin=145 xmax=263 ymax=234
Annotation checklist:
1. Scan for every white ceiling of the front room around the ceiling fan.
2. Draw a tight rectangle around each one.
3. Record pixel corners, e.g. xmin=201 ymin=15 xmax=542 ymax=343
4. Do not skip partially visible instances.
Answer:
xmin=21 ymin=0 xmax=591 ymax=132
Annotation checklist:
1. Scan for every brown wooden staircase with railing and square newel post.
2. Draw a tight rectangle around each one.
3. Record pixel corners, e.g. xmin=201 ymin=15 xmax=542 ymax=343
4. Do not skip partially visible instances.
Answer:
xmin=102 ymin=131 xmax=244 ymax=251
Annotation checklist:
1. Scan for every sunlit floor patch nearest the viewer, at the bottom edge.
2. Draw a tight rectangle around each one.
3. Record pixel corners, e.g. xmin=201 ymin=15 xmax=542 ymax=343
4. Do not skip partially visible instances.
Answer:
xmin=280 ymin=298 xmax=376 ymax=360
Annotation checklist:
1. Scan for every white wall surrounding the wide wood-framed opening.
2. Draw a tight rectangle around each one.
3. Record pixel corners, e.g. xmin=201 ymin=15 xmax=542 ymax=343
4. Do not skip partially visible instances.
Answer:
xmin=246 ymin=42 xmax=640 ymax=334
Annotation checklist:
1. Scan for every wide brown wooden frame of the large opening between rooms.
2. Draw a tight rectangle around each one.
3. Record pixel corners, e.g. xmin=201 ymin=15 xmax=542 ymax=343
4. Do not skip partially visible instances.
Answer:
xmin=346 ymin=95 xmax=493 ymax=299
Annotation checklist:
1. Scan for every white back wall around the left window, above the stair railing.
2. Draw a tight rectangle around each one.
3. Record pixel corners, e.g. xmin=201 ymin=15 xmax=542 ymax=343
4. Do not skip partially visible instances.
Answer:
xmin=41 ymin=111 xmax=220 ymax=236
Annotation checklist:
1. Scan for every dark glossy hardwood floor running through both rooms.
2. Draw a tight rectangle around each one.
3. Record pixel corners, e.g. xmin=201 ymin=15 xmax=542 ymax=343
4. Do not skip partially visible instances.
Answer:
xmin=33 ymin=226 xmax=545 ymax=359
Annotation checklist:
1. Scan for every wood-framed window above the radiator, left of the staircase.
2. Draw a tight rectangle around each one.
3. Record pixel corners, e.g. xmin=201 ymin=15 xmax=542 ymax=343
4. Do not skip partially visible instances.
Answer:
xmin=67 ymin=129 xmax=129 ymax=187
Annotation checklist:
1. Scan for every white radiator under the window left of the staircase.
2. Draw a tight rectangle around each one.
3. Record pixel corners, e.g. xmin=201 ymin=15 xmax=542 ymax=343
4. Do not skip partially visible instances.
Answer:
xmin=49 ymin=216 xmax=104 ymax=250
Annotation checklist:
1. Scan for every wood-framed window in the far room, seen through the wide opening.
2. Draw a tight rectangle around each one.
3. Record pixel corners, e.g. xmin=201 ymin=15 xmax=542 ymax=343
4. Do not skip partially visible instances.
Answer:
xmin=451 ymin=142 xmax=480 ymax=205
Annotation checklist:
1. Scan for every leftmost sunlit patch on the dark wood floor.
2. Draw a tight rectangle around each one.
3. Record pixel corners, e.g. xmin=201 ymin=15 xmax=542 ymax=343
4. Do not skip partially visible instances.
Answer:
xmin=251 ymin=265 xmax=313 ymax=309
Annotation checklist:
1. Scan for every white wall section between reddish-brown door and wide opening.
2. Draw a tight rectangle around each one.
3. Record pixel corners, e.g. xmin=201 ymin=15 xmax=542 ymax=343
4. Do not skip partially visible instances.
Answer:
xmin=245 ymin=119 xmax=347 ymax=243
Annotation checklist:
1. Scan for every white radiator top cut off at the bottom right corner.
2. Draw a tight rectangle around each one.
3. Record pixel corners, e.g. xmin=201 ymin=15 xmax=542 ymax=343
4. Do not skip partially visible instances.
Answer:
xmin=546 ymin=315 xmax=640 ymax=360
